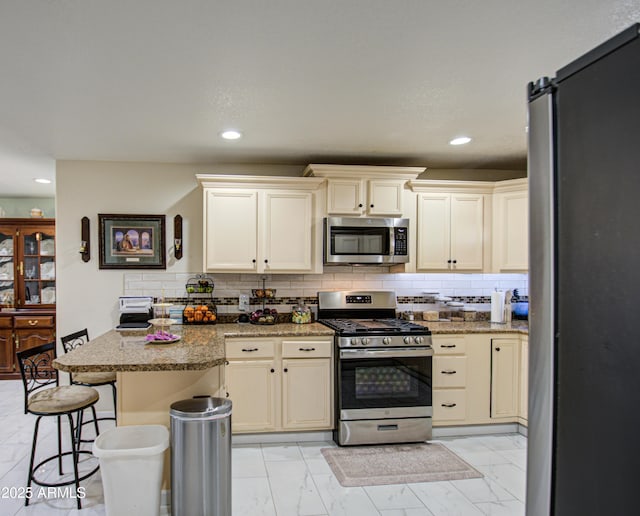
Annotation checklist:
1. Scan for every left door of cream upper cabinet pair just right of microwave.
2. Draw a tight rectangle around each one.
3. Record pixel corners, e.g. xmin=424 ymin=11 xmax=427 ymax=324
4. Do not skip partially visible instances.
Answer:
xmin=416 ymin=193 xmax=451 ymax=270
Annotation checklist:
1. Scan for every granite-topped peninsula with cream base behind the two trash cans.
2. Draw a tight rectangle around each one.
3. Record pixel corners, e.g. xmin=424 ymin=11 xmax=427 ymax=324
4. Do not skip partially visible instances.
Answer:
xmin=53 ymin=323 xmax=333 ymax=489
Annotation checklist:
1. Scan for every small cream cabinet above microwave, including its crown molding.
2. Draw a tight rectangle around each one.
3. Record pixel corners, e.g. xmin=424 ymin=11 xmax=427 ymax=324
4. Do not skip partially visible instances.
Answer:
xmin=304 ymin=164 xmax=425 ymax=217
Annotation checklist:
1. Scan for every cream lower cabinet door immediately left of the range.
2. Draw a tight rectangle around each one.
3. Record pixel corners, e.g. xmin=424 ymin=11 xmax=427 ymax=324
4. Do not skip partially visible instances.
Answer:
xmin=282 ymin=358 xmax=331 ymax=430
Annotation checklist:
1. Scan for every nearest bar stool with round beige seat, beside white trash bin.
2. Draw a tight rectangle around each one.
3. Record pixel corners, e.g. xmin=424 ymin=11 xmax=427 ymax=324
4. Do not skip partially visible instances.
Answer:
xmin=16 ymin=342 xmax=100 ymax=509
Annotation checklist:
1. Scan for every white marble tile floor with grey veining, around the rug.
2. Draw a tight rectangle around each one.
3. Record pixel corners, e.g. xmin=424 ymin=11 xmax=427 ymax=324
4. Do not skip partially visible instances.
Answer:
xmin=0 ymin=381 xmax=526 ymax=516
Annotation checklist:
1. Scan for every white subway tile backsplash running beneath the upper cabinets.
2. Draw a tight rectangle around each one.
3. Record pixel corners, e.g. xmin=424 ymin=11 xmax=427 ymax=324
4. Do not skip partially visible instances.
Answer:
xmin=123 ymin=266 xmax=528 ymax=313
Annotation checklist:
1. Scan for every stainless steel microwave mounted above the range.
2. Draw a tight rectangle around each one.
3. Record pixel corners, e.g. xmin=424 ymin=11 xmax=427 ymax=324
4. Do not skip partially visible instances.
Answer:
xmin=324 ymin=217 xmax=409 ymax=265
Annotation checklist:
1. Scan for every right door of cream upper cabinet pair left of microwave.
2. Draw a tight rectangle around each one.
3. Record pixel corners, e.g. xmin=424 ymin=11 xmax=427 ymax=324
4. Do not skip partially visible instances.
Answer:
xmin=258 ymin=191 xmax=313 ymax=272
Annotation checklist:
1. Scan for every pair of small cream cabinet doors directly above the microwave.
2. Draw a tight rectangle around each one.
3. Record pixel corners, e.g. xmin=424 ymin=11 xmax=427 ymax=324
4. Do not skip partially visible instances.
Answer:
xmin=327 ymin=179 xmax=405 ymax=217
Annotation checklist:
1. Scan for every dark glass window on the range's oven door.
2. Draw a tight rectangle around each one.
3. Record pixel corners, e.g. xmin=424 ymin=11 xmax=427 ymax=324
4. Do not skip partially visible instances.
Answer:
xmin=338 ymin=357 xmax=432 ymax=409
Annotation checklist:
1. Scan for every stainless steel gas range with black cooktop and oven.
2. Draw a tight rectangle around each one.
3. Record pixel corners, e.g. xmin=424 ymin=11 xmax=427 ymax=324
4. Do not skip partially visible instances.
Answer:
xmin=318 ymin=291 xmax=433 ymax=445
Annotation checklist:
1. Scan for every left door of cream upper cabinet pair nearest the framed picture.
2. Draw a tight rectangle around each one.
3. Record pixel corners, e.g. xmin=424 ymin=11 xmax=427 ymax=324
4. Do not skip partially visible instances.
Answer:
xmin=204 ymin=189 xmax=258 ymax=272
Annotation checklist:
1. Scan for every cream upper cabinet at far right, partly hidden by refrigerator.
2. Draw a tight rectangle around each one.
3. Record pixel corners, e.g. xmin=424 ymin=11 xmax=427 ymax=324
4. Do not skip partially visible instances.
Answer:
xmin=493 ymin=179 xmax=529 ymax=272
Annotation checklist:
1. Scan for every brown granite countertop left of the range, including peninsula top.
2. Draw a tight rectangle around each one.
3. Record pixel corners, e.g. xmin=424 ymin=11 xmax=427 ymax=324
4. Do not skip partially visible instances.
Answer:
xmin=53 ymin=323 xmax=333 ymax=373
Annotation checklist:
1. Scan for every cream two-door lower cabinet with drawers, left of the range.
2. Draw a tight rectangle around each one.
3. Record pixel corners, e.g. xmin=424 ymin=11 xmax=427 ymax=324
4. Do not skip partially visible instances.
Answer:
xmin=225 ymin=337 xmax=333 ymax=433
